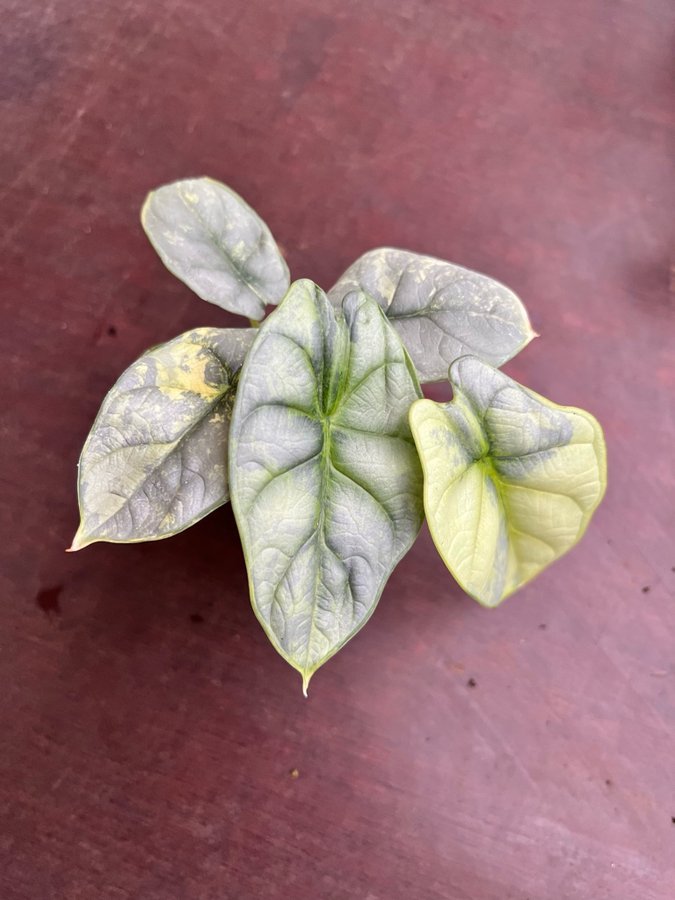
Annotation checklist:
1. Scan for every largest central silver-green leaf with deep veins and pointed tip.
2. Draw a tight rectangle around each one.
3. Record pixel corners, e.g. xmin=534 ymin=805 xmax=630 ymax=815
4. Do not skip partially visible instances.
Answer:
xmin=230 ymin=280 xmax=422 ymax=691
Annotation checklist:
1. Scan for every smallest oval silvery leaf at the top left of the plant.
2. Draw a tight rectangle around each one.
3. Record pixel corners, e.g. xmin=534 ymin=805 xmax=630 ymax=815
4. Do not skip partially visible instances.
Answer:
xmin=141 ymin=178 xmax=289 ymax=320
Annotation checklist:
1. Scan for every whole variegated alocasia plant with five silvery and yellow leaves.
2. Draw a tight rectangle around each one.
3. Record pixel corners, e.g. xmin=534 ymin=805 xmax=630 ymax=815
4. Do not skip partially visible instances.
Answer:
xmin=72 ymin=178 xmax=606 ymax=692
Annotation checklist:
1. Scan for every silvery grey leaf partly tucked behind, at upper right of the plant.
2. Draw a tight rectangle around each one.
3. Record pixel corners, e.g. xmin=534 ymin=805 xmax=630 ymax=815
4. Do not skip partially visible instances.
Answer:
xmin=328 ymin=247 xmax=536 ymax=382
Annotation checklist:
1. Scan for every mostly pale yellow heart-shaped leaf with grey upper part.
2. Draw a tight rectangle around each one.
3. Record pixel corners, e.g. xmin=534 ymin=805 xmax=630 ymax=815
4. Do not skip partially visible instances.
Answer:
xmin=410 ymin=357 xmax=606 ymax=606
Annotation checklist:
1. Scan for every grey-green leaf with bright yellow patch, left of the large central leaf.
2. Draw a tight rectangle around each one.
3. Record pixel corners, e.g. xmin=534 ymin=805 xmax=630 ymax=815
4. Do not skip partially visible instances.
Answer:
xmin=71 ymin=328 xmax=255 ymax=550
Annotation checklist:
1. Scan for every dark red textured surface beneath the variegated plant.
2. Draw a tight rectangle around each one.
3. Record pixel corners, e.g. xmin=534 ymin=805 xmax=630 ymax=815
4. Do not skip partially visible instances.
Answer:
xmin=0 ymin=0 xmax=675 ymax=900
